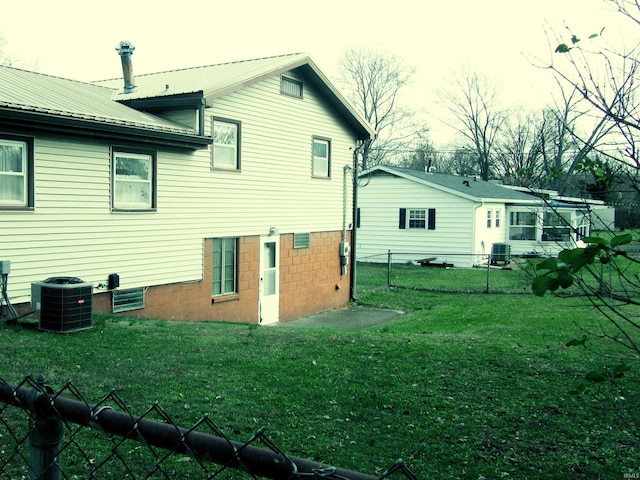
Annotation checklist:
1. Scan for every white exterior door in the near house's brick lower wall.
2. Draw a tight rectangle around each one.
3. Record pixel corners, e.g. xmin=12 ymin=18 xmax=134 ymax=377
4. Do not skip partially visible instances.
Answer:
xmin=259 ymin=235 xmax=280 ymax=325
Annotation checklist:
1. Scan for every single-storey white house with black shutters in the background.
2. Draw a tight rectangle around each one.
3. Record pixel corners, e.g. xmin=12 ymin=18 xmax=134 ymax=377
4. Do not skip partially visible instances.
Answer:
xmin=356 ymin=166 xmax=604 ymax=266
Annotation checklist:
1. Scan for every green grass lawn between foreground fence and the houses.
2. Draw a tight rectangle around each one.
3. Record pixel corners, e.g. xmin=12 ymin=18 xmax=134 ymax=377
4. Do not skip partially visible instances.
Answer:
xmin=0 ymin=278 xmax=640 ymax=480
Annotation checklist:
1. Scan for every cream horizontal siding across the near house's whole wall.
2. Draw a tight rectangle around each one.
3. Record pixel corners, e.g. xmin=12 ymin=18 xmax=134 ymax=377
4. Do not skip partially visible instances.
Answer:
xmin=0 ymin=71 xmax=355 ymax=304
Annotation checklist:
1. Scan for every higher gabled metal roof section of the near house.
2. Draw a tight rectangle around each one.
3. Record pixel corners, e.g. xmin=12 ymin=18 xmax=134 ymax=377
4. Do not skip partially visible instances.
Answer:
xmin=95 ymin=53 xmax=375 ymax=140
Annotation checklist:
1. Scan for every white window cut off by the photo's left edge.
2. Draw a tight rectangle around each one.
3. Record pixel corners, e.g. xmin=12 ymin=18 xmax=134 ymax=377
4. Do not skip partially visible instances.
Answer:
xmin=0 ymin=136 xmax=34 ymax=209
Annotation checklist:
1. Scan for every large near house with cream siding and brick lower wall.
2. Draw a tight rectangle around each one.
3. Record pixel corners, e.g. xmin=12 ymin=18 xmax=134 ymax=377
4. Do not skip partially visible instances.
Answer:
xmin=0 ymin=48 xmax=374 ymax=323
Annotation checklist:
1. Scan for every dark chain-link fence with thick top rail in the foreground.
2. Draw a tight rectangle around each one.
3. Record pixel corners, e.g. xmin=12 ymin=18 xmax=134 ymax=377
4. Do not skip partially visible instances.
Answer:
xmin=0 ymin=376 xmax=416 ymax=480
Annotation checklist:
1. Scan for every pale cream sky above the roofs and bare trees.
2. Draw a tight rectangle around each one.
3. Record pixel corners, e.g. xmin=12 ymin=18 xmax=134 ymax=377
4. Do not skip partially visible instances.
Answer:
xmin=0 ymin=0 xmax=638 ymax=144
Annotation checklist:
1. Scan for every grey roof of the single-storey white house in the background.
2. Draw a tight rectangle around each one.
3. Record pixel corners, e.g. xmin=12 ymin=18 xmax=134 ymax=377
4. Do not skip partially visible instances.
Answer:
xmin=362 ymin=166 xmax=540 ymax=204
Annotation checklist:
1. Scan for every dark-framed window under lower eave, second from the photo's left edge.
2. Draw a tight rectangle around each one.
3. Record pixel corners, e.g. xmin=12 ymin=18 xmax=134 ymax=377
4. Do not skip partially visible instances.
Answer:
xmin=111 ymin=149 xmax=156 ymax=210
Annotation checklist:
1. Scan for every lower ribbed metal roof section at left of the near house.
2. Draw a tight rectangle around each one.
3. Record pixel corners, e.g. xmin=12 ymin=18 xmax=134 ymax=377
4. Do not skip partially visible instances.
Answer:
xmin=0 ymin=66 xmax=204 ymax=136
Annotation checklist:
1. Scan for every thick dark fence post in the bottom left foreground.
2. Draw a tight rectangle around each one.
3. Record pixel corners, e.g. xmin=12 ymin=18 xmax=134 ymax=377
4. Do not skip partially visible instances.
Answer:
xmin=27 ymin=374 xmax=64 ymax=480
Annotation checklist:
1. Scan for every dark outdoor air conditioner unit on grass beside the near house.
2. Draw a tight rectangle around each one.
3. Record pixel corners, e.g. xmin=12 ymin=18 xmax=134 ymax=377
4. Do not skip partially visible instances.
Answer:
xmin=31 ymin=277 xmax=93 ymax=333
